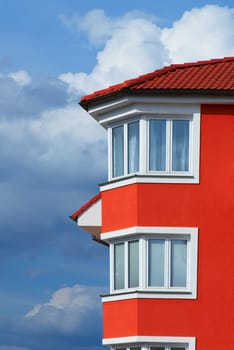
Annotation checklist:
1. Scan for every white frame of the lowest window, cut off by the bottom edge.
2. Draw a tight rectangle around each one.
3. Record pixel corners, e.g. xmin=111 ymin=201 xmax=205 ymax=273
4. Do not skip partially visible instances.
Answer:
xmin=102 ymin=336 xmax=196 ymax=350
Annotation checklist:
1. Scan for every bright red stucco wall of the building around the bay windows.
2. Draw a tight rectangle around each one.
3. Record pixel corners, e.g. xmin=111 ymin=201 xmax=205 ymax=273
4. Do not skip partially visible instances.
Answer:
xmin=102 ymin=105 xmax=234 ymax=350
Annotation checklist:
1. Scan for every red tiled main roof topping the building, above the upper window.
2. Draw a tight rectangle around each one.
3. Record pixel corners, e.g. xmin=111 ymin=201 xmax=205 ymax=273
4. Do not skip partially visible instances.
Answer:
xmin=80 ymin=57 xmax=234 ymax=108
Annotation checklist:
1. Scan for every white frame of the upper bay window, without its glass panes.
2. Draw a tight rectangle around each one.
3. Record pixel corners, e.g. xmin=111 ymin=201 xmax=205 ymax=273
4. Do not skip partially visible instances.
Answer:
xmin=106 ymin=112 xmax=200 ymax=191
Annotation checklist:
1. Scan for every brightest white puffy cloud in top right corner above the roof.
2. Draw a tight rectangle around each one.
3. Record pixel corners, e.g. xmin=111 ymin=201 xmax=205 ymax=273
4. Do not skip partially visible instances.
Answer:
xmin=162 ymin=5 xmax=234 ymax=63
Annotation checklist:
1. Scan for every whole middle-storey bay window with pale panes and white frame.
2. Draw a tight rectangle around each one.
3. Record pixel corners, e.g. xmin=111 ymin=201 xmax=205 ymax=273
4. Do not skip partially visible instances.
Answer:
xmin=101 ymin=227 xmax=198 ymax=299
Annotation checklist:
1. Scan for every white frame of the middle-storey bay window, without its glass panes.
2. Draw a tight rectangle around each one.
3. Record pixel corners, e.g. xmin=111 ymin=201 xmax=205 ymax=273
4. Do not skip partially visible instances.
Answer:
xmin=101 ymin=226 xmax=198 ymax=301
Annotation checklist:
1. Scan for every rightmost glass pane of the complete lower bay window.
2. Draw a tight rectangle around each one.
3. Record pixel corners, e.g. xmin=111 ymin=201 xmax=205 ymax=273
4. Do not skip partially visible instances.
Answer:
xmin=171 ymin=239 xmax=187 ymax=287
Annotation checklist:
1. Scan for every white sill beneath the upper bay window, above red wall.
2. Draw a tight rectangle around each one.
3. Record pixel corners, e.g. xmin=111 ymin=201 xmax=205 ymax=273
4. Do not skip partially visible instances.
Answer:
xmin=100 ymin=173 xmax=199 ymax=191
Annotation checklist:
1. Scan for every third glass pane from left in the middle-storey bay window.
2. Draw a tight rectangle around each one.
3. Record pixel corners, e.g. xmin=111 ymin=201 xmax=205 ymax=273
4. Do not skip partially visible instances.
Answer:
xmin=148 ymin=239 xmax=165 ymax=287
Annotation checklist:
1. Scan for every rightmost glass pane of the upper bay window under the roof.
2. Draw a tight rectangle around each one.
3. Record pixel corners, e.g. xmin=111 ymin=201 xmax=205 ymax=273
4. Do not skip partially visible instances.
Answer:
xmin=172 ymin=120 xmax=189 ymax=171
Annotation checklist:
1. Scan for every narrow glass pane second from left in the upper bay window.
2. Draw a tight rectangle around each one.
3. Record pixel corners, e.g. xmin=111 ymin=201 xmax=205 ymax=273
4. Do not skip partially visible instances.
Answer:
xmin=128 ymin=121 xmax=139 ymax=173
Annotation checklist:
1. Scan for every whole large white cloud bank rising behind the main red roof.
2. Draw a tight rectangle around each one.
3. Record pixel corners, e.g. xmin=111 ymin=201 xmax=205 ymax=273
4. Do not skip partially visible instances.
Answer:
xmin=59 ymin=5 xmax=234 ymax=94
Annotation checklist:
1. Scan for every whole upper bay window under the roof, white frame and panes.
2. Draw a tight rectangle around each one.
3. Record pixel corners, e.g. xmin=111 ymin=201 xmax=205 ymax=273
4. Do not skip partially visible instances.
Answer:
xmin=106 ymin=113 xmax=200 ymax=187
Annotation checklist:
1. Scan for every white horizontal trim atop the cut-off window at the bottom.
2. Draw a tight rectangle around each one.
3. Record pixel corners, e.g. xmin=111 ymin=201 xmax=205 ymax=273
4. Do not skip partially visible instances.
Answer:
xmin=102 ymin=336 xmax=196 ymax=350
